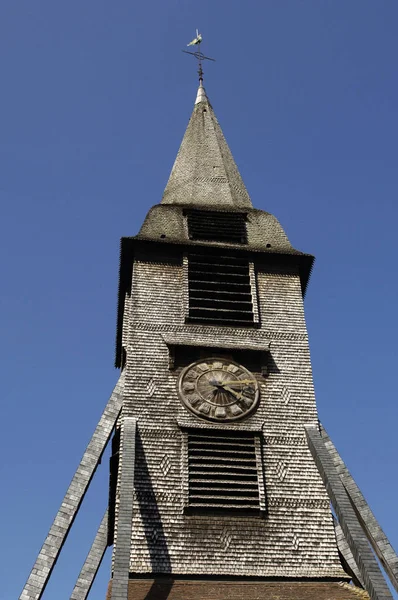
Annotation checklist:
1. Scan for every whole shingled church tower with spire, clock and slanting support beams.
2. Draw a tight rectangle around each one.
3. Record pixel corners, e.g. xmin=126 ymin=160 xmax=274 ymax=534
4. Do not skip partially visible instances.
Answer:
xmin=21 ymin=76 xmax=398 ymax=600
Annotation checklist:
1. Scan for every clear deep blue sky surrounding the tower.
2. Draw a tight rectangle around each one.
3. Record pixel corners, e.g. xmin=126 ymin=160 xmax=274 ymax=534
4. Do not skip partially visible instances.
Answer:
xmin=0 ymin=0 xmax=398 ymax=600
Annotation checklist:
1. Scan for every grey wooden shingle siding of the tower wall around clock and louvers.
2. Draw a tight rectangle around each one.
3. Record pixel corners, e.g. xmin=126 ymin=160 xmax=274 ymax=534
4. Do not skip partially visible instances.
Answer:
xmin=116 ymin=260 xmax=344 ymax=578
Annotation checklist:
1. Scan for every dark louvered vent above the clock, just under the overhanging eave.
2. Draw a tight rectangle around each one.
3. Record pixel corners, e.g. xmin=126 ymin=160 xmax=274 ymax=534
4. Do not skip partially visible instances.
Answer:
xmin=188 ymin=254 xmax=254 ymax=325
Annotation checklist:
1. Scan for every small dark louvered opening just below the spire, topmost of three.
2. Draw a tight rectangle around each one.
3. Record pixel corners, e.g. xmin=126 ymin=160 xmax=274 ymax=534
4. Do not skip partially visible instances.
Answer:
xmin=187 ymin=210 xmax=247 ymax=244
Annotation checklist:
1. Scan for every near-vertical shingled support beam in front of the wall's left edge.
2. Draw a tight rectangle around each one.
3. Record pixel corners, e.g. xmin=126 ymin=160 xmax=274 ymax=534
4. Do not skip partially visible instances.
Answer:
xmin=111 ymin=416 xmax=137 ymax=600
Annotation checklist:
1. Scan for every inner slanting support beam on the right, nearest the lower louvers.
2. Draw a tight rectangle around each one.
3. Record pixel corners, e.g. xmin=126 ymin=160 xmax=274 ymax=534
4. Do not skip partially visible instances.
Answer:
xmin=305 ymin=425 xmax=393 ymax=600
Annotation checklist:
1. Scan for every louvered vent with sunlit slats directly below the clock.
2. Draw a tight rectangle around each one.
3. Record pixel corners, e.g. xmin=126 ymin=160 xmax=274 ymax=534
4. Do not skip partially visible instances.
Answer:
xmin=188 ymin=430 xmax=260 ymax=510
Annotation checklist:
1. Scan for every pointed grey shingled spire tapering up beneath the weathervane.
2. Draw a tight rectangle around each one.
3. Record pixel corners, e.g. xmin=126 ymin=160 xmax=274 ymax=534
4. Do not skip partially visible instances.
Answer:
xmin=162 ymin=84 xmax=252 ymax=210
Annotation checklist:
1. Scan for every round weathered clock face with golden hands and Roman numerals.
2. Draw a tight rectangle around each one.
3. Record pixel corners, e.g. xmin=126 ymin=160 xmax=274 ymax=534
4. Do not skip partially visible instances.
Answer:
xmin=178 ymin=358 xmax=260 ymax=421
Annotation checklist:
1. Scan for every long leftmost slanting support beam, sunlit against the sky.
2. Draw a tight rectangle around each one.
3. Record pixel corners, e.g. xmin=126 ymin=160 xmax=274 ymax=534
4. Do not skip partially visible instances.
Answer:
xmin=19 ymin=376 xmax=124 ymax=600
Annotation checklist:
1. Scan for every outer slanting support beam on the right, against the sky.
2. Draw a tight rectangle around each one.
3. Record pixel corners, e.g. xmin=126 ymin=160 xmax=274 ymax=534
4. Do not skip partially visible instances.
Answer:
xmin=321 ymin=425 xmax=398 ymax=592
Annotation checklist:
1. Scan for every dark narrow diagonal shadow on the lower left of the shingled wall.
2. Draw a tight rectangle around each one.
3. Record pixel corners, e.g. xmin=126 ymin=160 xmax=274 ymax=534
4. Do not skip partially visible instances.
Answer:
xmin=135 ymin=430 xmax=173 ymax=600
